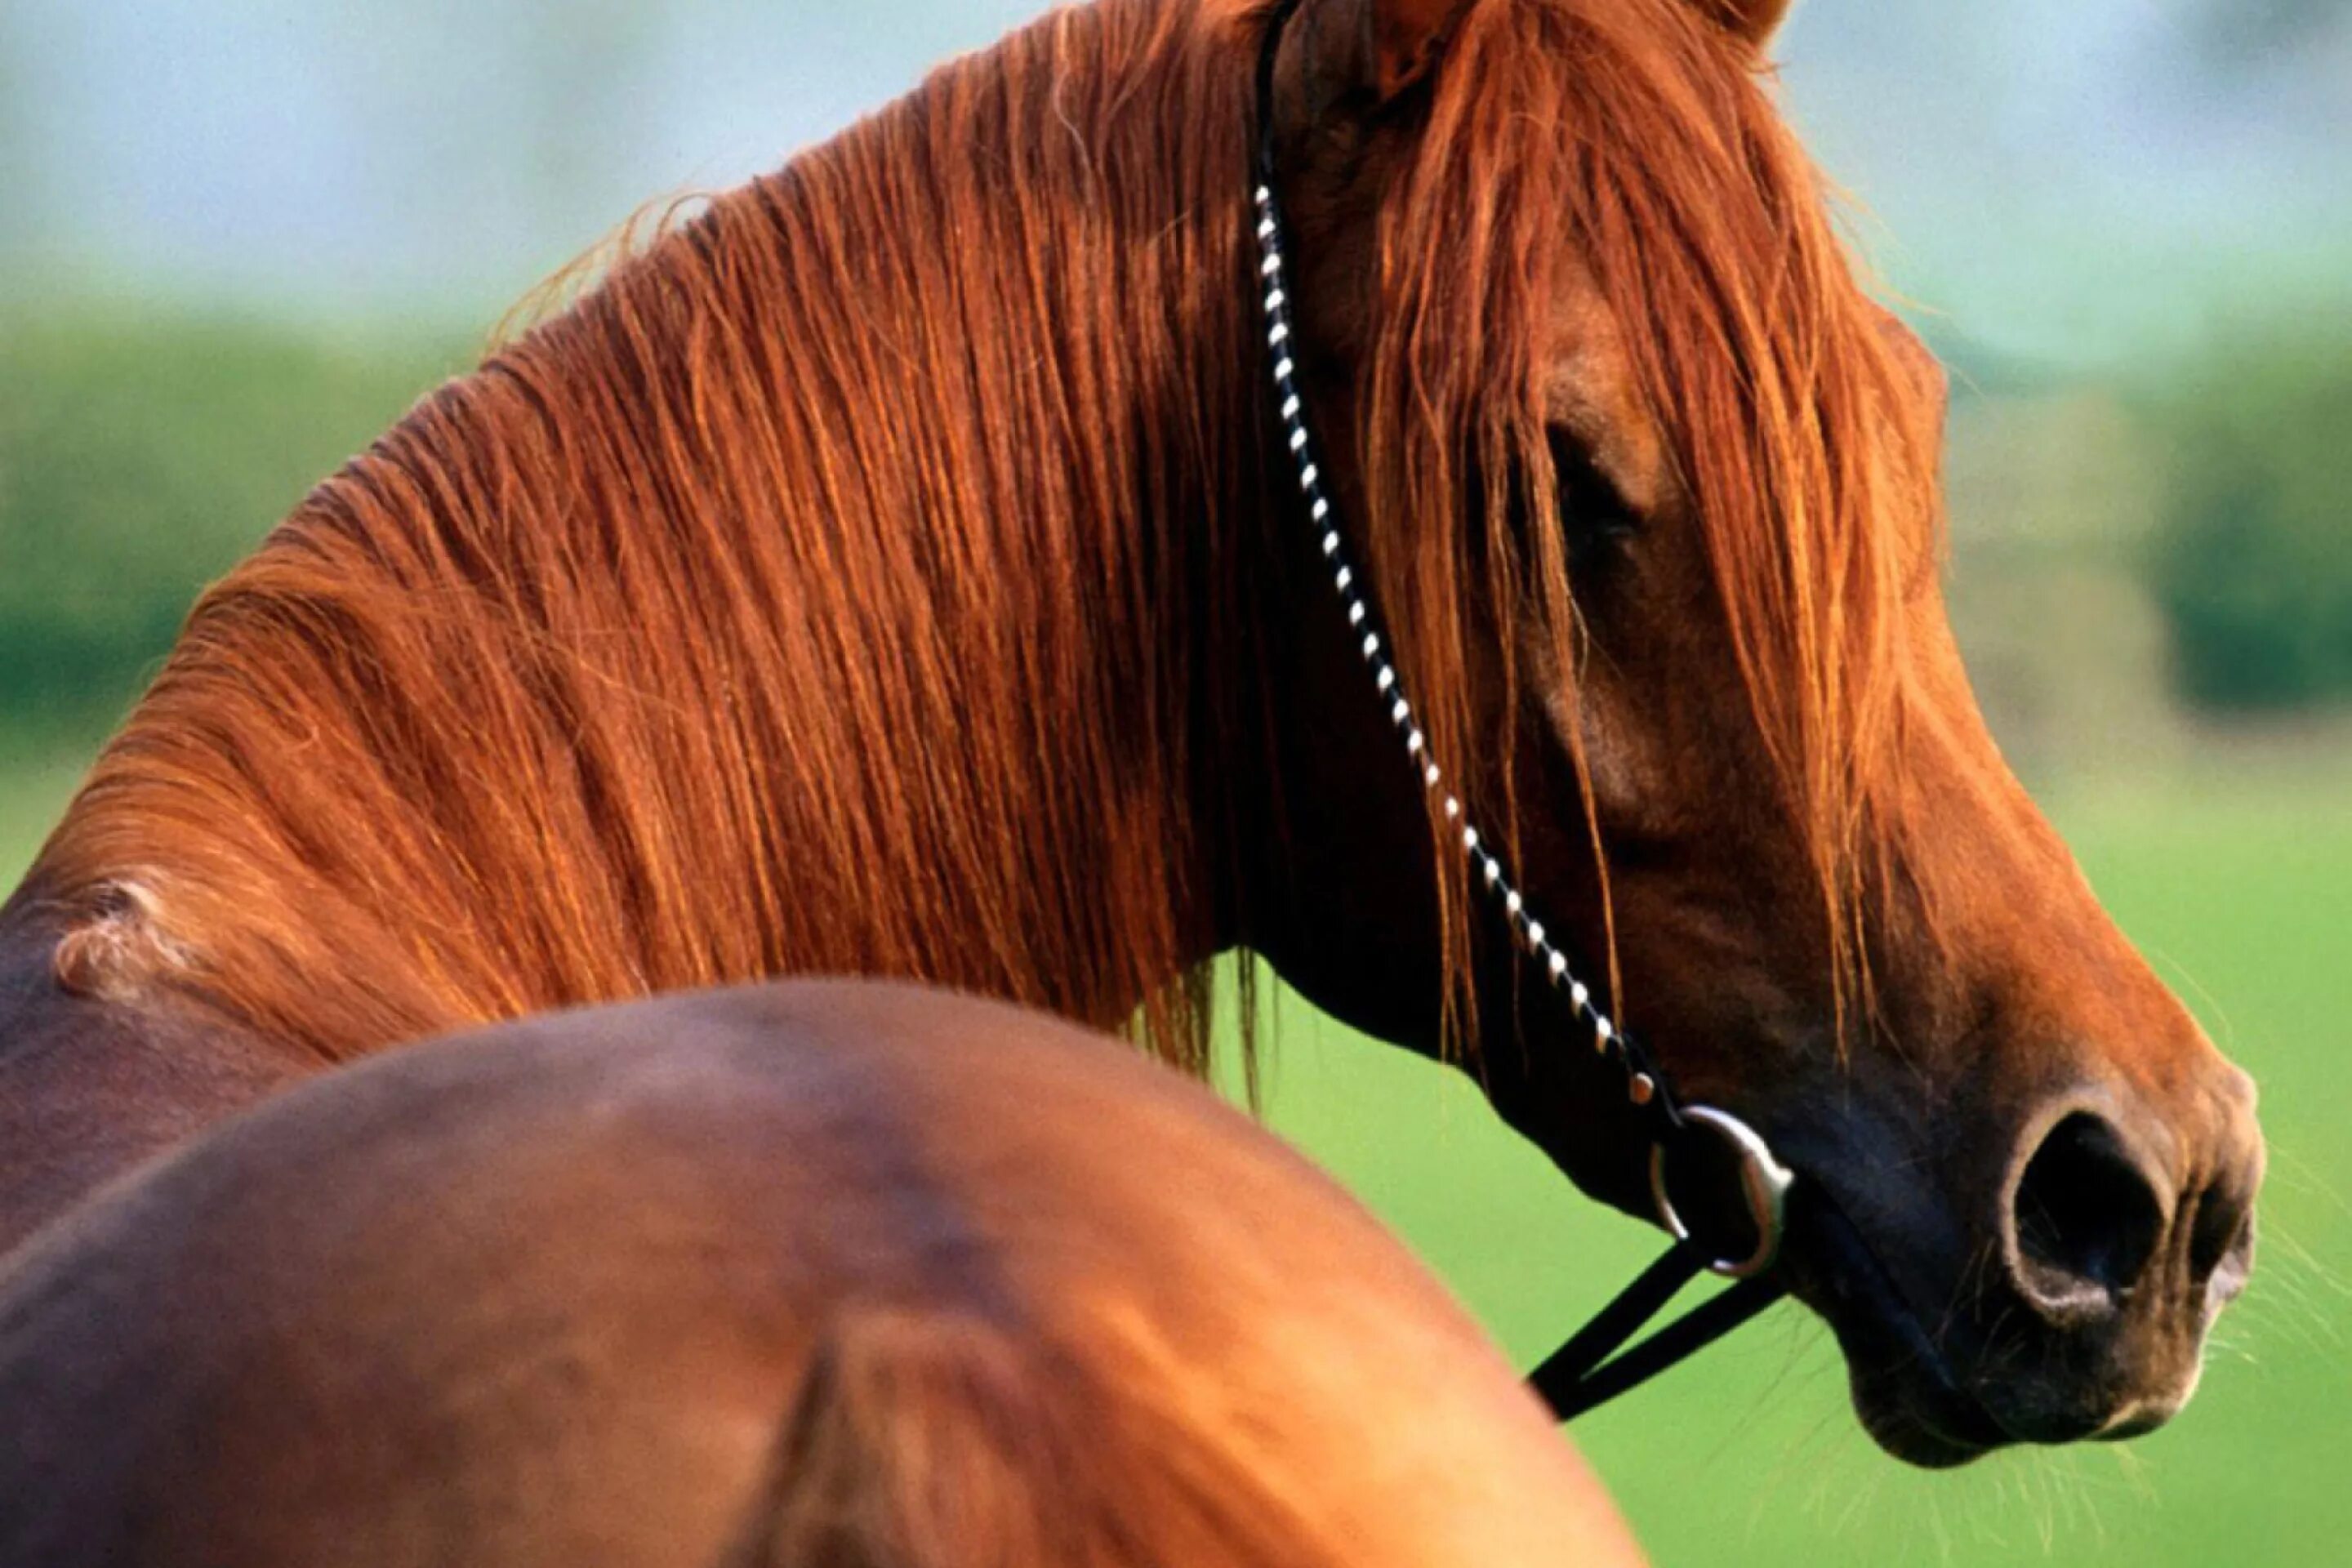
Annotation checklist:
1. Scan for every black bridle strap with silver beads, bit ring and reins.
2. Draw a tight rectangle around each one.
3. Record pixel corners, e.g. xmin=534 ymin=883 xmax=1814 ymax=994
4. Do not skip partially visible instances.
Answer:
xmin=1254 ymin=0 xmax=1794 ymax=1420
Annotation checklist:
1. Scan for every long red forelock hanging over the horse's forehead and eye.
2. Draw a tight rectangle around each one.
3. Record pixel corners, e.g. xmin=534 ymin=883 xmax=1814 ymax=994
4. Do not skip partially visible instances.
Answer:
xmin=1360 ymin=0 xmax=1940 ymax=1053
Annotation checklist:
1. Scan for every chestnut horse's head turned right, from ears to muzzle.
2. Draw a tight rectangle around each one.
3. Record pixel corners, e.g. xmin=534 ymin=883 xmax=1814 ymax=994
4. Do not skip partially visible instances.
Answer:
xmin=1251 ymin=0 xmax=2263 ymax=1464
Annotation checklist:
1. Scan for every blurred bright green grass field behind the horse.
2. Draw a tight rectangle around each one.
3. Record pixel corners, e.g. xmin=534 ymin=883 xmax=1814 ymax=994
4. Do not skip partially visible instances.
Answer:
xmin=0 ymin=746 xmax=2352 ymax=1568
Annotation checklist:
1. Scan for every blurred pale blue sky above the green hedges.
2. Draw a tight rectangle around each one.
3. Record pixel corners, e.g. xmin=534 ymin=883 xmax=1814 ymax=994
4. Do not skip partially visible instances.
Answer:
xmin=0 ymin=0 xmax=2352 ymax=362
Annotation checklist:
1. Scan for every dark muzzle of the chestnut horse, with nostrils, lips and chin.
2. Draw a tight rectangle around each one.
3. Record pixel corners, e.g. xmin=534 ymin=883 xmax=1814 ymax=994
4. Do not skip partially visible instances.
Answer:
xmin=1783 ymin=1070 xmax=2263 ymax=1467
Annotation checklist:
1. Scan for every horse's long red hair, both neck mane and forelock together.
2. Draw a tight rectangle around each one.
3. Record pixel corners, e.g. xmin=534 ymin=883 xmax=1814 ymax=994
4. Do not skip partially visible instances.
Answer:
xmin=35 ymin=0 xmax=1933 ymax=1062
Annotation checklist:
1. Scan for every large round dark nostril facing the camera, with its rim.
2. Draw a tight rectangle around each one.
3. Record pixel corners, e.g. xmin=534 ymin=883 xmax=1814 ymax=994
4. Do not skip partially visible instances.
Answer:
xmin=2007 ymin=1112 xmax=2164 ymax=1314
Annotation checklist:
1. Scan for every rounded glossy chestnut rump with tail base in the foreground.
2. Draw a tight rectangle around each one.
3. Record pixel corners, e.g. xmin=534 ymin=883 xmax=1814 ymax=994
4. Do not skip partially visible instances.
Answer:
xmin=0 ymin=980 xmax=1637 ymax=1568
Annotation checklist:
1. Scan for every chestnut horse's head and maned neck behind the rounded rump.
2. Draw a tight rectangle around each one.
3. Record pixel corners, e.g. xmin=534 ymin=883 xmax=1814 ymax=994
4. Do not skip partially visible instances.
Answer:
xmin=0 ymin=0 xmax=2263 ymax=1464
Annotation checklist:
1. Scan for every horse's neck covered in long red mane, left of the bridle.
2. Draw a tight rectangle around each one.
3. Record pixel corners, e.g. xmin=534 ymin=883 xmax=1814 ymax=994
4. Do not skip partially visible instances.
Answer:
xmin=35 ymin=2 xmax=1265 ymax=1058
